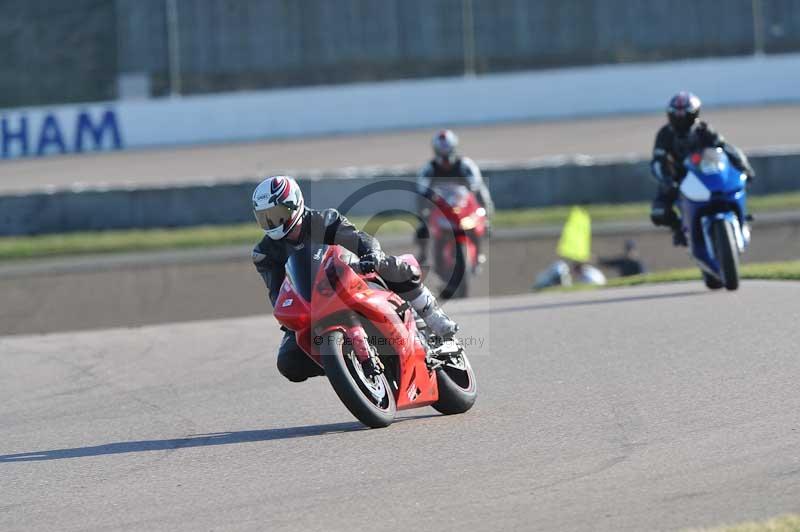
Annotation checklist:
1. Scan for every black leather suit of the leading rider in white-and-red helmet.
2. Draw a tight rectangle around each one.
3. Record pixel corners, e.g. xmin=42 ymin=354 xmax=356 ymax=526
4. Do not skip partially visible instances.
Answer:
xmin=253 ymin=208 xmax=422 ymax=382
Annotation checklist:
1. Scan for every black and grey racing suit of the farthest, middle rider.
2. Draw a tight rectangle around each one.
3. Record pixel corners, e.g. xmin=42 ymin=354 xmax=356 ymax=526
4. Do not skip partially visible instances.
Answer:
xmin=417 ymin=157 xmax=494 ymax=256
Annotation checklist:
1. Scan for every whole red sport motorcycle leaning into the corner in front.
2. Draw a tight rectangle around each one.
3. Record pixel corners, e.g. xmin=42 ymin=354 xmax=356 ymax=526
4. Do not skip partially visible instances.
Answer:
xmin=275 ymin=244 xmax=477 ymax=428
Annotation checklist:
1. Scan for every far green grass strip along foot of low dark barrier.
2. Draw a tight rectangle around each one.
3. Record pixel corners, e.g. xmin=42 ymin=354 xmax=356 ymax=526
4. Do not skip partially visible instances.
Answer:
xmin=0 ymin=193 xmax=800 ymax=261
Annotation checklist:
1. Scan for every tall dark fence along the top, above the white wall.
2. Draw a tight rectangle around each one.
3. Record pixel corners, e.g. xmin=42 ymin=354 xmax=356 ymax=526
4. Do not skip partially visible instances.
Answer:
xmin=0 ymin=0 xmax=800 ymax=108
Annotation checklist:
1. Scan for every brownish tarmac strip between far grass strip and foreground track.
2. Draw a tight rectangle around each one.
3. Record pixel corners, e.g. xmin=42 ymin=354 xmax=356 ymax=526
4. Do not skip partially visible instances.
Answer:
xmin=6 ymin=219 xmax=800 ymax=335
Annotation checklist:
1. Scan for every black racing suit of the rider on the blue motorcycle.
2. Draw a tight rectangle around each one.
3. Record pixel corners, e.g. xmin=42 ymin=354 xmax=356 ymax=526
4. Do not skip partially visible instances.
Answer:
xmin=650 ymin=122 xmax=755 ymax=231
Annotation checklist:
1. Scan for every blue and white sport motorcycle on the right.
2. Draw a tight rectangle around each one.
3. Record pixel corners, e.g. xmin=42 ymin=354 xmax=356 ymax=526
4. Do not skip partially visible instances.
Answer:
xmin=679 ymin=148 xmax=750 ymax=290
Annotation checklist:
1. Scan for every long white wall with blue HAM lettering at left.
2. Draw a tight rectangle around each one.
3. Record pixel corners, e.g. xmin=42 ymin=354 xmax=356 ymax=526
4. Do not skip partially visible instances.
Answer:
xmin=0 ymin=54 xmax=800 ymax=158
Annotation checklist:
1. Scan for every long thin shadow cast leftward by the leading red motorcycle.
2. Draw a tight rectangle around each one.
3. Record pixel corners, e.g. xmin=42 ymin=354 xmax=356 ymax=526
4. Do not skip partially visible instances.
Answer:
xmin=0 ymin=414 xmax=439 ymax=465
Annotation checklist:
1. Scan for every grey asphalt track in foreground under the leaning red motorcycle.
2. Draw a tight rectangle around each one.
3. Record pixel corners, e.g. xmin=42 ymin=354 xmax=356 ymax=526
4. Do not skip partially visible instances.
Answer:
xmin=0 ymin=282 xmax=800 ymax=531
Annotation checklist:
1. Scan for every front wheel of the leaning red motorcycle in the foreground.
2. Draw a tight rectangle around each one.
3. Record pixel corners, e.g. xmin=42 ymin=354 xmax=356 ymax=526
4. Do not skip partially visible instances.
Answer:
xmin=320 ymin=331 xmax=397 ymax=428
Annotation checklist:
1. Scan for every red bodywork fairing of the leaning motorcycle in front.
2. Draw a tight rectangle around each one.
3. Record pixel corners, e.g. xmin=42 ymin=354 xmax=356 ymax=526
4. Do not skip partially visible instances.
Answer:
xmin=275 ymin=246 xmax=439 ymax=409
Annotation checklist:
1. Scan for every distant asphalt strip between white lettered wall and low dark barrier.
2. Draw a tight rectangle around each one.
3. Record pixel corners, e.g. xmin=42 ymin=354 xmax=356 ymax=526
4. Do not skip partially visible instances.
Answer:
xmin=0 ymin=103 xmax=800 ymax=194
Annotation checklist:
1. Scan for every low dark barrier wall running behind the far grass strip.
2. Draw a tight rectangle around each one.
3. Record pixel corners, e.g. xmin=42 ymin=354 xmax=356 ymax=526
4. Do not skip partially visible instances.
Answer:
xmin=0 ymin=150 xmax=800 ymax=235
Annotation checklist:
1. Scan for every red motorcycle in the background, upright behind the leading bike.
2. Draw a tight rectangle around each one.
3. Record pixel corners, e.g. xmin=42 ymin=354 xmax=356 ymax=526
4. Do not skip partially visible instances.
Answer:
xmin=428 ymin=183 xmax=486 ymax=298
